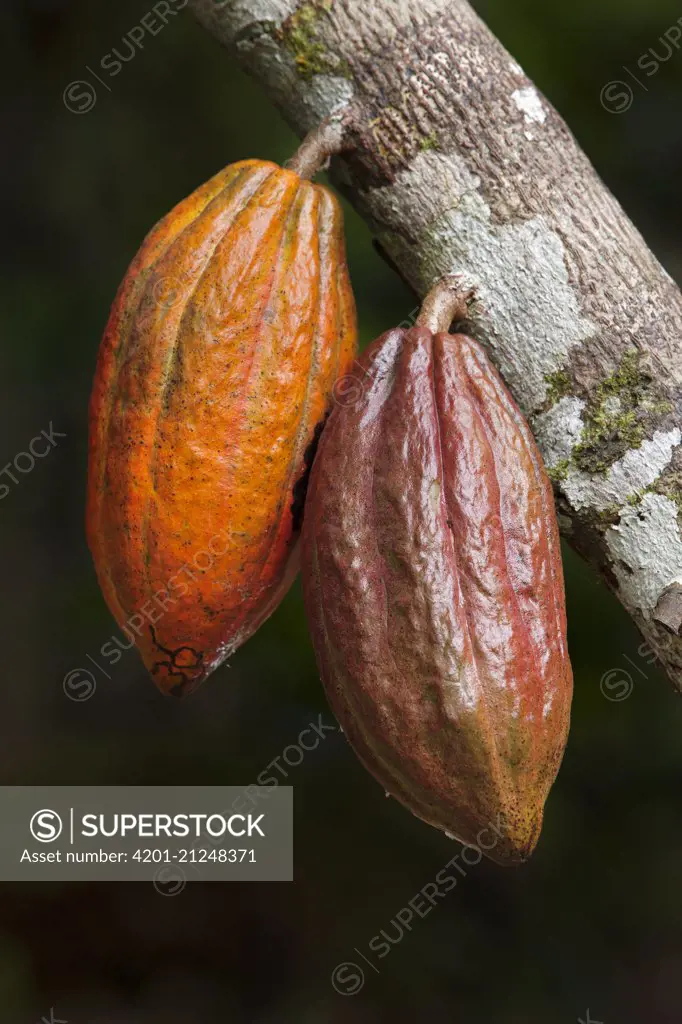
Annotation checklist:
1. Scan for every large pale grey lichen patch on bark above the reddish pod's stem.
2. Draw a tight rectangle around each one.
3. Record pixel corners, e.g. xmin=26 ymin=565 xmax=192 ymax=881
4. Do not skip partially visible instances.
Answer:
xmin=360 ymin=151 xmax=595 ymax=414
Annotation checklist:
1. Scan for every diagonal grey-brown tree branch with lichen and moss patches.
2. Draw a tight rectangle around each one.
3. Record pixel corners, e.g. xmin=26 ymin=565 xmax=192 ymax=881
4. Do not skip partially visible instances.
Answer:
xmin=190 ymin=0 xmax=682 ymax=691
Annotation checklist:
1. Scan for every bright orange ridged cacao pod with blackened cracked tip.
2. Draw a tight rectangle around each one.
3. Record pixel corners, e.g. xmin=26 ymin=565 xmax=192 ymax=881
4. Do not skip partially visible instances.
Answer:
xmin=87 ymin=160 xmax=356 ymax=694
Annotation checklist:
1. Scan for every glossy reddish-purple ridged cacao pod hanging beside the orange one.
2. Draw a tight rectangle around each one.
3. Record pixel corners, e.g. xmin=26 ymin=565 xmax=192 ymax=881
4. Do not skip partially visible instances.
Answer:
xmin=302 ymin=327 xmax=572 ymax=863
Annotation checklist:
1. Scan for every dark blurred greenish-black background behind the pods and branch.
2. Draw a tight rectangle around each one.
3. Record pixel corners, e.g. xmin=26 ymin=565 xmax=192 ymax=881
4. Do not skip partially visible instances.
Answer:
xmin=0 ymin=0 xmax=682 ymax=1024
